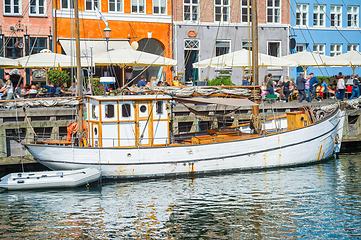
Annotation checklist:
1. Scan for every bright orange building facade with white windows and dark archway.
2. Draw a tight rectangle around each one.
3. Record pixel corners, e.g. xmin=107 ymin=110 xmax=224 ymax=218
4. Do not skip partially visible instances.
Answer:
xmin=53 ymin=0 xmax=172 ymax=83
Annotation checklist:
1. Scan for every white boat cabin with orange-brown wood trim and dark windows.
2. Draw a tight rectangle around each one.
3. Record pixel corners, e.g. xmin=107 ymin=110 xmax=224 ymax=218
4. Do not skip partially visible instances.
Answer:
xmin=84 ymin=95 xmax=172 ymax=147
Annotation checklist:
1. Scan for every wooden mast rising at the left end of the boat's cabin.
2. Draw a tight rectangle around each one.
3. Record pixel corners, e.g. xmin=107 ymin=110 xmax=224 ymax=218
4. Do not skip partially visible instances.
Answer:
xmin=74 ymin=0 xmax=83 ymax=146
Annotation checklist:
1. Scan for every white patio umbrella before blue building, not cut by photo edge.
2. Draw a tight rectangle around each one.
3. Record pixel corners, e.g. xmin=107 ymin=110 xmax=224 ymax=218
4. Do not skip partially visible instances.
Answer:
xmin=281 ymin=51 xmax=349 ymax=71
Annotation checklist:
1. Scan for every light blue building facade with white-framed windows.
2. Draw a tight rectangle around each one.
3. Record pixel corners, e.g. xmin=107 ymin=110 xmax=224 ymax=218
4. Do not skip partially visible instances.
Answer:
xmin=289 ymin=0 xmax=361 ymax=78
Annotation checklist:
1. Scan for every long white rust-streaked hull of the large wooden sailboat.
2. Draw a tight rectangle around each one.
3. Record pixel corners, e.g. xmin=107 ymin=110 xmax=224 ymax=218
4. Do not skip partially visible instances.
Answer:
xmin=26 ymin=110 xmax=345 ymax=179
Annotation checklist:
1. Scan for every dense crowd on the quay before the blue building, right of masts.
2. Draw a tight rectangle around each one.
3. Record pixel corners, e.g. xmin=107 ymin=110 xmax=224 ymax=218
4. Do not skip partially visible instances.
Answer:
xmin=258 ymin=72 xmax=360 ymax=103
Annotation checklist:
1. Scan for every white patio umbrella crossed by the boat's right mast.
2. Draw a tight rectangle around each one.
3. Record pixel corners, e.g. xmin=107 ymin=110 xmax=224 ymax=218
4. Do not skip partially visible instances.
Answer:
xmin=193 ymin=49 xmax=296 ymax=68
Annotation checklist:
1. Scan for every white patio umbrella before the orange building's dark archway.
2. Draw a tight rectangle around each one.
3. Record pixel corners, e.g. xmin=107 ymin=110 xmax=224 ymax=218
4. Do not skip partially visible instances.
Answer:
xmin=93 ymin=48 xmax=177 ymax=67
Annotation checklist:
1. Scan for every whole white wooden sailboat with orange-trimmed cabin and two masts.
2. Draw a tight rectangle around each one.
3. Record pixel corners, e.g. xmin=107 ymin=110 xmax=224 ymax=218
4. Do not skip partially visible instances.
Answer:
xmin=20 ymin=1 xmax=345 ymax=179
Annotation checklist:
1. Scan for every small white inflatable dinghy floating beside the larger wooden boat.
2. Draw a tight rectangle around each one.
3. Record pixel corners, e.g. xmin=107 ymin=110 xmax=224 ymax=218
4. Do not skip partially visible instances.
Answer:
xmin=0 ymin=168 xmax=101 ymax=190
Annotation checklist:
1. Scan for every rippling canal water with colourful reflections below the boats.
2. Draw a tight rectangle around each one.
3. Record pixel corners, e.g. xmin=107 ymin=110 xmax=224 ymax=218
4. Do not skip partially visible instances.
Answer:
xmin=0 ymin=152 xmax=361 ymax=239
